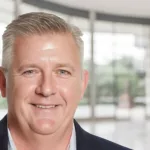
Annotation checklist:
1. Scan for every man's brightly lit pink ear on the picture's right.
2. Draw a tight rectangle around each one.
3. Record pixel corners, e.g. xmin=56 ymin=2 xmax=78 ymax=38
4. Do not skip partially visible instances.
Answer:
xmin=81 ymin=70 xmax=89 ymax=98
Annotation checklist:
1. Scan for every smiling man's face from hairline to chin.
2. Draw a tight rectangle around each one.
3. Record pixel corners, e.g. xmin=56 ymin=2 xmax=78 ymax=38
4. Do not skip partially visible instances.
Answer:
xmin=0 ymin=33 xmax=88 ymax=134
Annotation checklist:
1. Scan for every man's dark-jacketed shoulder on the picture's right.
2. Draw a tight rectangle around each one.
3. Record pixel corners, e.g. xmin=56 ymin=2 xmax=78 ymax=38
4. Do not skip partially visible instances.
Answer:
xmin=75 ymin=121 xmax=131 ymax=150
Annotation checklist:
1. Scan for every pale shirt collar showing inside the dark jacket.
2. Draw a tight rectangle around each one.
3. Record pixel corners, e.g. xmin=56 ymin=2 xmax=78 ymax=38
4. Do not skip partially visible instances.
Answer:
xmin=7 ymin=125 xmax=76 ymax=150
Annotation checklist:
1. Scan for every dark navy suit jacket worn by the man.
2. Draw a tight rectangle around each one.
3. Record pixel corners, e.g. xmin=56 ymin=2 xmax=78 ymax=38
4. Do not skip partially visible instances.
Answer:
xmin=0 ymin=116 xmax=130 ymax=150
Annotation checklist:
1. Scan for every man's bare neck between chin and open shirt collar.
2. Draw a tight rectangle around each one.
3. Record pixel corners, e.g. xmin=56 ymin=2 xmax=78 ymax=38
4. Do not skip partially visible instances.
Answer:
xmin=8 ymin=117 xmax=73 ymax=150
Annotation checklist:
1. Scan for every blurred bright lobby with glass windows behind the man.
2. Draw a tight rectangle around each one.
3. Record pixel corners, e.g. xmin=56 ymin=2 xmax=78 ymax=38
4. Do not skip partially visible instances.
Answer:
xmin=0 ymin=0 xmax=150 ymax=150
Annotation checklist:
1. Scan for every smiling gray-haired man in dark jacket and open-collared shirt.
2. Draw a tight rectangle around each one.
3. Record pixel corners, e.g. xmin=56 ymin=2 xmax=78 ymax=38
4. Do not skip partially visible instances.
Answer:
xmin=0 ymin=13 xmax=131 ymax=150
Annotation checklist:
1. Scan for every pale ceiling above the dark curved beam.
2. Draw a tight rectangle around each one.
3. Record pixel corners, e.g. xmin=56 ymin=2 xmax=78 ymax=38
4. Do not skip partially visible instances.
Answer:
xmin=45 ymin=0 xmax=150 ymax=18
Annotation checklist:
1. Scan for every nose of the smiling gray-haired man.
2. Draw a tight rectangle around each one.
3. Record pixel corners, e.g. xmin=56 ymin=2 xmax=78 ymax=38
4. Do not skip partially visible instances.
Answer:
xmin=35 ymin=74 xmax=56 ymax=97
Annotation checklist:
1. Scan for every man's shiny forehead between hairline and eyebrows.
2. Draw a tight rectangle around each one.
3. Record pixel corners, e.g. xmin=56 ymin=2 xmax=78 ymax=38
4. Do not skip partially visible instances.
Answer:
xmin=14 ymin=33 xmax=80 ymax=67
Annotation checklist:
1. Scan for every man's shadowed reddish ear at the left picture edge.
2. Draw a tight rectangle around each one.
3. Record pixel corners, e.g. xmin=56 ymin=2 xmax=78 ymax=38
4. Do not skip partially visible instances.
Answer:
xmin=0 ymin=67 xmax=6 ymax=97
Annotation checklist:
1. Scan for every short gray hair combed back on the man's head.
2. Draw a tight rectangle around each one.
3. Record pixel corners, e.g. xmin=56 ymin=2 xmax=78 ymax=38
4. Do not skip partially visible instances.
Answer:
xmin=2 ymin=12 xmax=84 ymax=70
